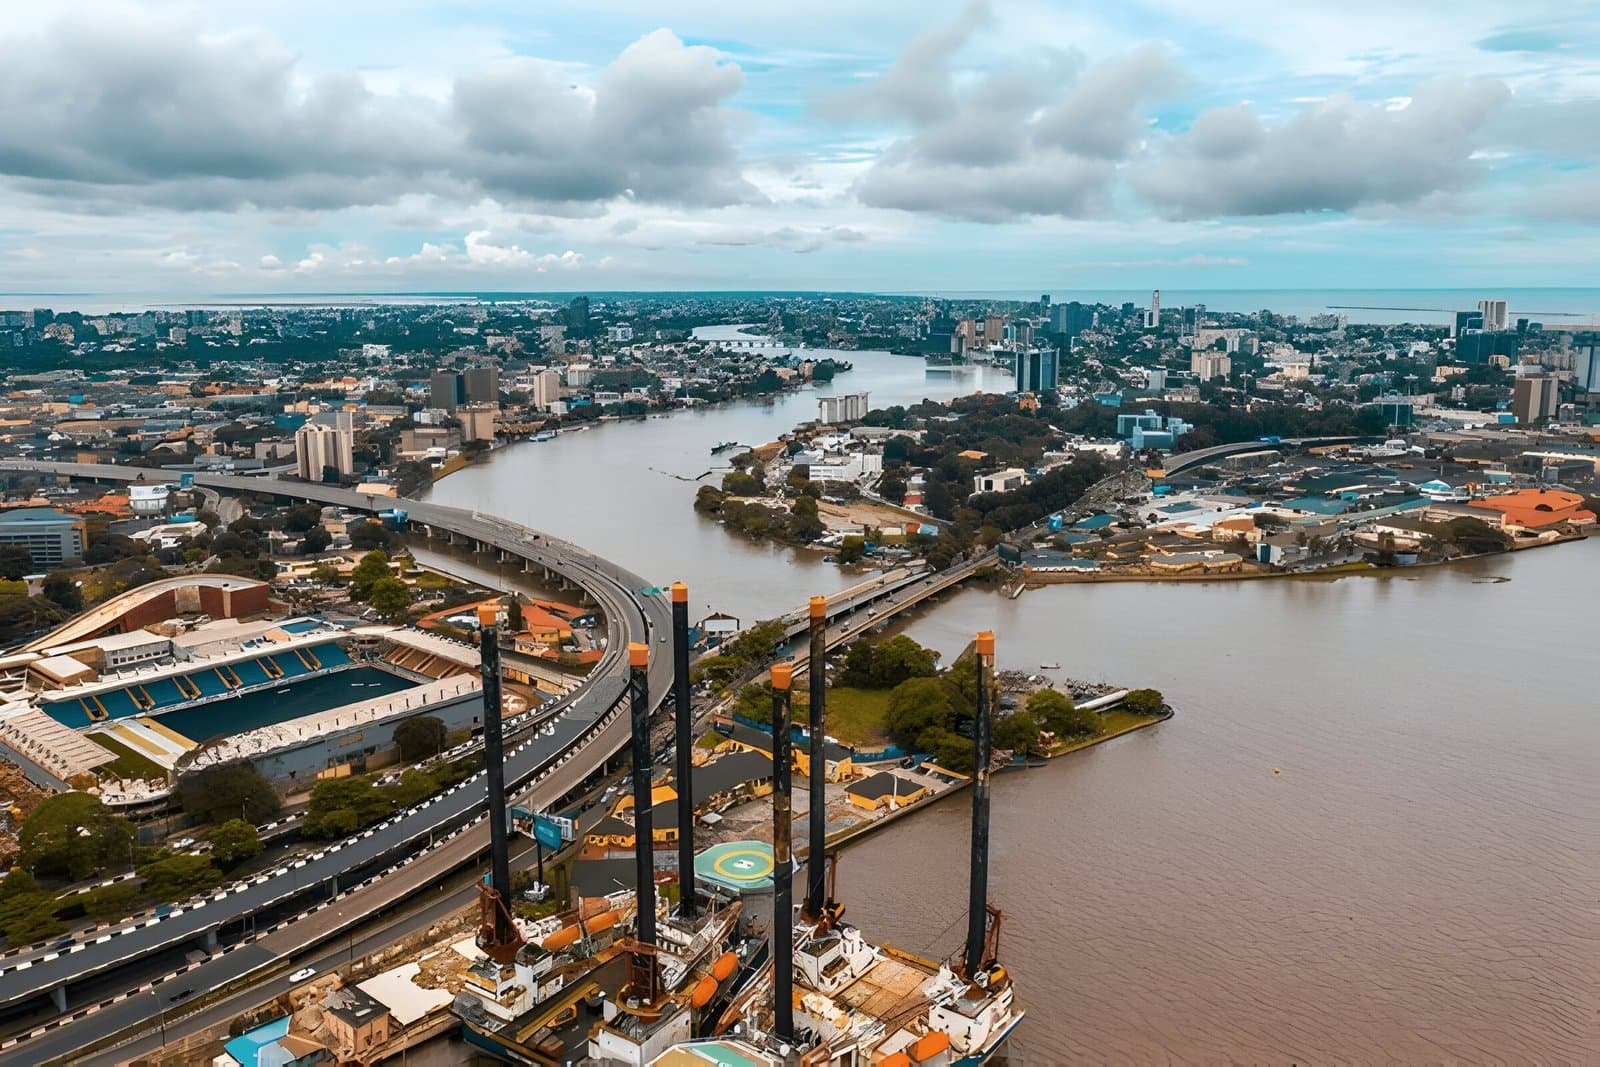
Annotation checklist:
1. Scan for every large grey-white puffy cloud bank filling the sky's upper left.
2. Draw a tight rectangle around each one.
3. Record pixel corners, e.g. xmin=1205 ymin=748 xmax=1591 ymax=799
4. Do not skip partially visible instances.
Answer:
xmin=0 ymin=13 xmax=757 ymax=211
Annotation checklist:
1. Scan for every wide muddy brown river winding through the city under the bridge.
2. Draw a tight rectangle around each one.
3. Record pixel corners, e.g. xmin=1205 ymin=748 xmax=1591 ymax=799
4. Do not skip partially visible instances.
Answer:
xmin=434 ymin=329 xmax=1600 ymax=1064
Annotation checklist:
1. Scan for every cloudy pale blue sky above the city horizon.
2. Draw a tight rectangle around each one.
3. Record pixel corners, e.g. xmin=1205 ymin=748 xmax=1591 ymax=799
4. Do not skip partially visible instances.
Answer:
xmin=0 ymin=0 xmax=1600 ymax=296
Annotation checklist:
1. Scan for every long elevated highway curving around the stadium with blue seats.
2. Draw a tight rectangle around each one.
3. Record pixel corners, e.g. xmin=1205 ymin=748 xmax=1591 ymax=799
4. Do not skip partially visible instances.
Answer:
xmin=0 ymin=461 xmax=672 ymax=1062
